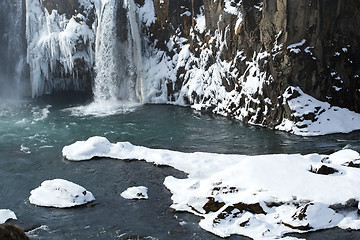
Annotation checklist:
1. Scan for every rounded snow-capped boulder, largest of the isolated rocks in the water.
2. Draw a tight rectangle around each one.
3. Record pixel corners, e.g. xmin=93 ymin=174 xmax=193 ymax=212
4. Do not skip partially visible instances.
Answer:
xmin=29 ymin=179 xmax=95 ymax=208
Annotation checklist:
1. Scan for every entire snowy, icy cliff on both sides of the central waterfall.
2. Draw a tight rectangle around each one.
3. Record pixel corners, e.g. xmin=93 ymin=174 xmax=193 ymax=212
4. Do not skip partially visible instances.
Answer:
xmin=21 ymin=0 xmax=360 ymax=135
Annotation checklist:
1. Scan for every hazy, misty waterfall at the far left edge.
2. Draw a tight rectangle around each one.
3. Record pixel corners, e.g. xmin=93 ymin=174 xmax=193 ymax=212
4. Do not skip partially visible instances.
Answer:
xmin=0 ymin=0 xmax=27 ymax=99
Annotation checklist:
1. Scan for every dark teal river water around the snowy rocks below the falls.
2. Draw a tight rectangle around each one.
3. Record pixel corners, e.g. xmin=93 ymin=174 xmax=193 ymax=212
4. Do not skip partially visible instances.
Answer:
xmin=0 ymin=96 xmax=360 ymax=239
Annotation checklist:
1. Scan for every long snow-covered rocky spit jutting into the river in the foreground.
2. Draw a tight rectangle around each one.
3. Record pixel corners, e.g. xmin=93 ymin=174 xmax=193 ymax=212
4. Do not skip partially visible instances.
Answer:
xmin=63 ymin=137 xmax=360 ymax=239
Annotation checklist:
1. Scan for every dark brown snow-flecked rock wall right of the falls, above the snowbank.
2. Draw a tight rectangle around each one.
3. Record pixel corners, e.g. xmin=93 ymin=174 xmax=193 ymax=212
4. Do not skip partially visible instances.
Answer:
xmin=141 ymin=0 xmax=360 ymax=131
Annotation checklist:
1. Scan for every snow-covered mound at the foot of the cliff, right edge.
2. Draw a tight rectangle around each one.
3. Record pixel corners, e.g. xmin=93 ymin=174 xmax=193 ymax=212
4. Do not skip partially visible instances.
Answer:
xmin=275 ymin=87 xmax=360 ymax=136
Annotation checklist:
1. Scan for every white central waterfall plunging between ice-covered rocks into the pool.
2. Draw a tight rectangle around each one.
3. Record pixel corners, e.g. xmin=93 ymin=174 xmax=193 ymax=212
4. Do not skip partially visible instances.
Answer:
xmin=93 ymin=0 xmax=142 ymax=102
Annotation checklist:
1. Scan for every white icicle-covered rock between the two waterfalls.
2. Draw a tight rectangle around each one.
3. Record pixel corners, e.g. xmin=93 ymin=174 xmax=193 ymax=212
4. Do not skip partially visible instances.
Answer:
xmin=26 ymin=0 xmax=95 ymax=97
